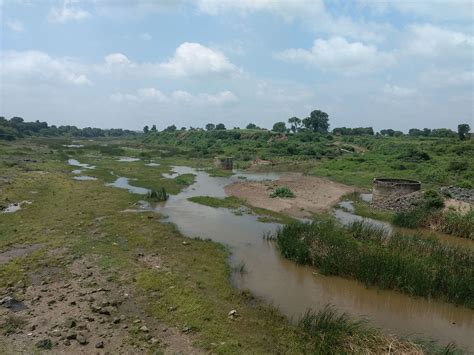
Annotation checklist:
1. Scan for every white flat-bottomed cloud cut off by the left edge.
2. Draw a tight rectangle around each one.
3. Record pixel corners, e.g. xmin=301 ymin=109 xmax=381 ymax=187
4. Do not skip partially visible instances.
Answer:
xmin=0 ymin=51 xmax=92 ymax=85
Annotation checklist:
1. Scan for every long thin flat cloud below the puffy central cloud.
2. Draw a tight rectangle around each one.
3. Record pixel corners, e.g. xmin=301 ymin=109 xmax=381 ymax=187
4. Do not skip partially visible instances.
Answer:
xmin=110 ymin=88 xmax=239 ymax=106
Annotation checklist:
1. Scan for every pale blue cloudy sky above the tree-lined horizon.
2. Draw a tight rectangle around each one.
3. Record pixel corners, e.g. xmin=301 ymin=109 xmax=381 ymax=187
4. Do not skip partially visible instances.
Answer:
xmin=0 ymin=0 xmax=474 ymax=131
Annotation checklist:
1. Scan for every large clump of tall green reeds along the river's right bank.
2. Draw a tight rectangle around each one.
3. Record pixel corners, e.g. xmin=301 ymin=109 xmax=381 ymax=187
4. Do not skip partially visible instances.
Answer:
xmin=276 ymin=219 xmax=474 ymax=308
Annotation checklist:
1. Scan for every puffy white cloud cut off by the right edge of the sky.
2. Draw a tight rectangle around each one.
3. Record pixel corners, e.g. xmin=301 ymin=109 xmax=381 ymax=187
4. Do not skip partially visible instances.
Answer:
xmin=408 ymin=24 xmax=474 ymax=57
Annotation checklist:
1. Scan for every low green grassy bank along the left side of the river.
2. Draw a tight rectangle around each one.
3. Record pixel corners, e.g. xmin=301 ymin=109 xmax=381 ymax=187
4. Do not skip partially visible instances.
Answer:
xmin=0 ymin=140 xmax=452 ymax=353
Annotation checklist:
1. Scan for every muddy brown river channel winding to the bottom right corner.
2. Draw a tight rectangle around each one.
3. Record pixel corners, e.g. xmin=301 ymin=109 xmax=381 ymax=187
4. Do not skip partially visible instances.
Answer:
xmin=110 ymin=166 xmax=474 ymax=351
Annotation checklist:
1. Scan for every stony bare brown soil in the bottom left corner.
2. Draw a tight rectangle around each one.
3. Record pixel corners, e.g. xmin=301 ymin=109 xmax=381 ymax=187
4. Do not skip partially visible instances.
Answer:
xmin=0 ymin=255 xmax=201 ymax=354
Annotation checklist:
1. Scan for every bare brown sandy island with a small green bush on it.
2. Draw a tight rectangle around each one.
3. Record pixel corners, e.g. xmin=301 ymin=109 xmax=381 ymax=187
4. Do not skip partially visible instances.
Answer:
xmin=225 ymin=174 xmax=355 ymax=218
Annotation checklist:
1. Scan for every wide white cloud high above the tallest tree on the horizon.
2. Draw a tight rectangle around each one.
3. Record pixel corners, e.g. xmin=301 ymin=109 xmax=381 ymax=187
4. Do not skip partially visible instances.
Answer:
xmin=275 ymin=37 xmax=395 ymax=75
